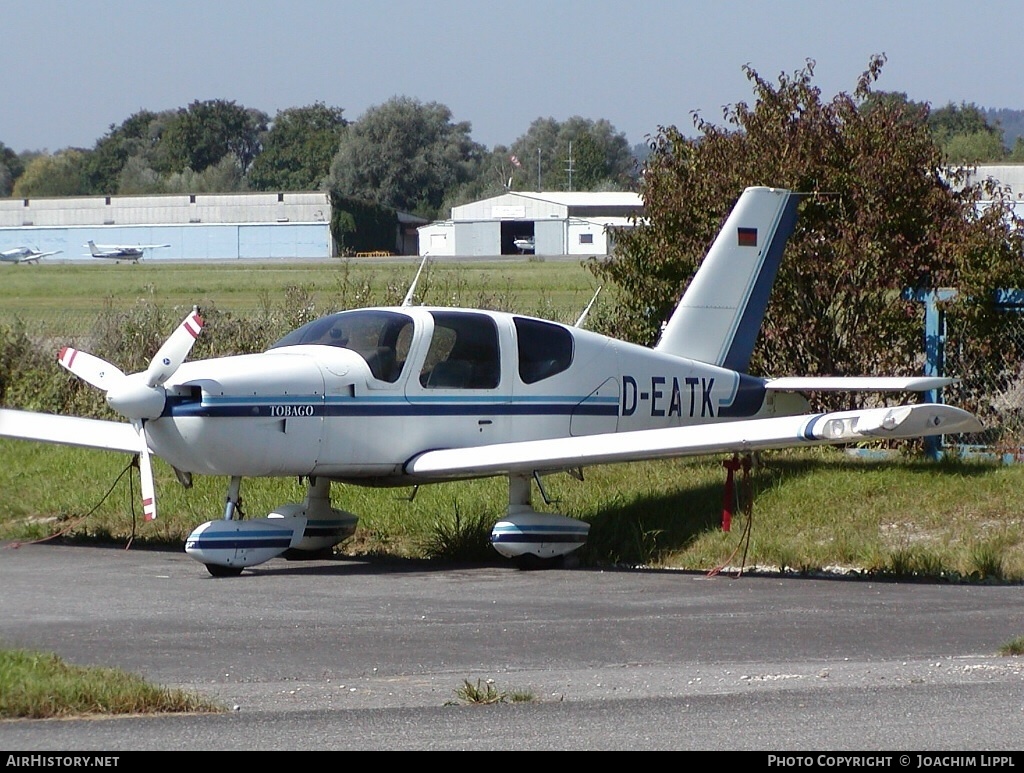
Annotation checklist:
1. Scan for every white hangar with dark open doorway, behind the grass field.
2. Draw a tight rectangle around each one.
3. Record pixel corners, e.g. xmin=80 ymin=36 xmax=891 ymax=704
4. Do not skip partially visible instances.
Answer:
xmin=419 ymin=191 xmax=643 ymax=257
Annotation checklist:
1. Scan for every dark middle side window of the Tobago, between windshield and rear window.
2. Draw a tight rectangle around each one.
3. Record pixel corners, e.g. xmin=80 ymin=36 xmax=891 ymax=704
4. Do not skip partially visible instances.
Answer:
xmin=420 ymin=311 xmax=501 ymax=389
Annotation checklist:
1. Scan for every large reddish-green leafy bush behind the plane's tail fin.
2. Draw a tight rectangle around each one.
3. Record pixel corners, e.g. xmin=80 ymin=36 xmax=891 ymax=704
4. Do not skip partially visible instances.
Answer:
xmin=593 ymin=56 xmax=1024 ymax=395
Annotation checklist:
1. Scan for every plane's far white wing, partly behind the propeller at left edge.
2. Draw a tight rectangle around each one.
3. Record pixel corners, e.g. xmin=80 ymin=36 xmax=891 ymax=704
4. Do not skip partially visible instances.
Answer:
xmin=0 ymin=409 xmax=142 ymax=454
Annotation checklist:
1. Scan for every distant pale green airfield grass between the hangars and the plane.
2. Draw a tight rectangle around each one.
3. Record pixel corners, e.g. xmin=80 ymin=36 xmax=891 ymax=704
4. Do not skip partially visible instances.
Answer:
xmin=0 ymin=258 xmax=598 ymax=335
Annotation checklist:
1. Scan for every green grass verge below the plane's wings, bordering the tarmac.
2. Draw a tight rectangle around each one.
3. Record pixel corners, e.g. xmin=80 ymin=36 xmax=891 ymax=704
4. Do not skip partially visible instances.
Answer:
xmin=0 ymin=440 xmax=1024 ymax=583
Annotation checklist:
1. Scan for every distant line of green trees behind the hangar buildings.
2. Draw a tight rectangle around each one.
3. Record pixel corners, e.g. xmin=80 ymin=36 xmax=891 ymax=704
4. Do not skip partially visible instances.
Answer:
xmin=0 ymin=91 xmax=1024 ymax=231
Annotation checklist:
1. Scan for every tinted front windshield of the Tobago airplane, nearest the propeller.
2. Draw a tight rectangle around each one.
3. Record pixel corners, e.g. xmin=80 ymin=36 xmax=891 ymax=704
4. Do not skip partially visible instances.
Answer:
xmin=270 ymin=310 xmax=413 ymax=383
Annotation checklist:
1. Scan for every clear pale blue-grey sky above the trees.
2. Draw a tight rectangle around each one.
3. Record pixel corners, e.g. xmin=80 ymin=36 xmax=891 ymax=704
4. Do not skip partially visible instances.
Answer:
xmin=0 ymin=0 xmax=1024 ymax=153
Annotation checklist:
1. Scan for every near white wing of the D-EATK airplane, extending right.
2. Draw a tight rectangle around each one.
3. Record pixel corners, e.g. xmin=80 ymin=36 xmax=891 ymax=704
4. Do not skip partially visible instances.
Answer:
xmin=406 ymin=403 xmax=982 ymax=479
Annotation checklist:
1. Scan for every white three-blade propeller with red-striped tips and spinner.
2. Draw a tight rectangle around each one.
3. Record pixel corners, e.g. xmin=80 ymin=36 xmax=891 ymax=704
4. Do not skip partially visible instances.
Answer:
xmin=57 ymin=307 xmax=203 ymax=521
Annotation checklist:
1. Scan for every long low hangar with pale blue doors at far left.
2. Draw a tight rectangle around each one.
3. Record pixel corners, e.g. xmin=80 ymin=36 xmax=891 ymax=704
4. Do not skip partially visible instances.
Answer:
xmin=0 ymin=192 xmax=335 ymax=260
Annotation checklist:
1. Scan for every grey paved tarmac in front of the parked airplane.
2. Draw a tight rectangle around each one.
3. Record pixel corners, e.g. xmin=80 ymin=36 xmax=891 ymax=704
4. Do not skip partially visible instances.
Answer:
xmin=0 ymin=544 xmax=1024 ymax=753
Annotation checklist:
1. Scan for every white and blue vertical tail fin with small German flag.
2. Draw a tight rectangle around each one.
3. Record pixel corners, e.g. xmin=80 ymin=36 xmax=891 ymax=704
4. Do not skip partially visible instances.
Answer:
xmin=654 ymin=187 xmax=801 ymax=372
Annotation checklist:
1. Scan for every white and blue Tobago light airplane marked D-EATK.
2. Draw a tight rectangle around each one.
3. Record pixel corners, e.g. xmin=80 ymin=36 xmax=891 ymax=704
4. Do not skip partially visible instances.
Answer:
xmin=0 ymin=187 xmax=981 ymax=576
